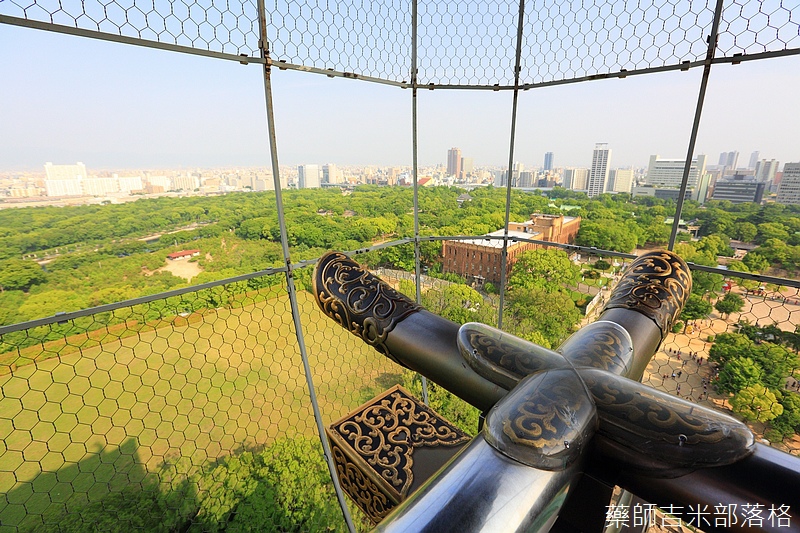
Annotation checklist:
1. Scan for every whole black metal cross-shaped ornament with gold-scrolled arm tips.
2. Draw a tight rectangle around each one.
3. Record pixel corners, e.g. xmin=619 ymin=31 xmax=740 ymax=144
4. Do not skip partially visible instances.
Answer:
xmin=314 ymin=252 xmax=800 ymax=531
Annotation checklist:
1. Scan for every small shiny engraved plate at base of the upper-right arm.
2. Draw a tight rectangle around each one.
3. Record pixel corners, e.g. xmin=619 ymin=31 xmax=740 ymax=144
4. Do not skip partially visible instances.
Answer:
xmin=557 ymin=320 xmax=633 ymax=375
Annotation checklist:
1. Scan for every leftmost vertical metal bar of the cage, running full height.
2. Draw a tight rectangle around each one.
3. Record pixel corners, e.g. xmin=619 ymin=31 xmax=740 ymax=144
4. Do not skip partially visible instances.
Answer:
xmin=258 ymin=0 xmax=356 ymax=533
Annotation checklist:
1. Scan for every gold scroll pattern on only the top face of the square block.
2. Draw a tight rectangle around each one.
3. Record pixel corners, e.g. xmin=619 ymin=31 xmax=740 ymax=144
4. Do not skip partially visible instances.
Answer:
xmin=334 ymin=386 xmax=469 ymax=500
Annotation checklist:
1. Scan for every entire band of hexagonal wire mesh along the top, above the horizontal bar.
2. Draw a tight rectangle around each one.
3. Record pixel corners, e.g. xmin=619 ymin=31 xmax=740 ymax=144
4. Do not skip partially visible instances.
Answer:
xmin=0 ymin=0 xmax=800 ymax=83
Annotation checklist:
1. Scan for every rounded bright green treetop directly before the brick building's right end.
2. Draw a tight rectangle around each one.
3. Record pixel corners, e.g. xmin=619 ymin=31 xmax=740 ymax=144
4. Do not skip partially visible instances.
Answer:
xmin=508 ymin=249 xmax=580 ymax=292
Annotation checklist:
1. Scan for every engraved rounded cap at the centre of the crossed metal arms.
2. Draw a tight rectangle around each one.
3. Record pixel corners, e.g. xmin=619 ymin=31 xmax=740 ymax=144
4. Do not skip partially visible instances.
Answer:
xmin=484 ymin=368 xmax=596 ymax=470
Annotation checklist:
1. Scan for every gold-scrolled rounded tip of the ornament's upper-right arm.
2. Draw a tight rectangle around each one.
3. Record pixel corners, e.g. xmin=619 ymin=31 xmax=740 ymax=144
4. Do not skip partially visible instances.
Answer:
xmin=605 ymin=250 xmax=692 ymax=336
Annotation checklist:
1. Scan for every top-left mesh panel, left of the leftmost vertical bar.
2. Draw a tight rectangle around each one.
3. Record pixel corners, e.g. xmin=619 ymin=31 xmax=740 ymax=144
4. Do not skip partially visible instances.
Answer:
xmin=0 ymin=0 xmax=258 ymax=56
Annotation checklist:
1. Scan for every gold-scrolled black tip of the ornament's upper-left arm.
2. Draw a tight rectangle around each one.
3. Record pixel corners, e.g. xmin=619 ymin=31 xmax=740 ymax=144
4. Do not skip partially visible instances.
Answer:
xmin=314 ymin=252 xmax=422 ymax=360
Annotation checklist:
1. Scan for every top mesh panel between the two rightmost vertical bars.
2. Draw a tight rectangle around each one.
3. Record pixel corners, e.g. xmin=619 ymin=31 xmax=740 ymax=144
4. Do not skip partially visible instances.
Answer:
xmin=520 ymin=0 xmax=714 ymax=83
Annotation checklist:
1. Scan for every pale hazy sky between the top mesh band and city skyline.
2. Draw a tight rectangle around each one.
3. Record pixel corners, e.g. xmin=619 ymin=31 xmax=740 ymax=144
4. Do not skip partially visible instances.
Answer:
xmin=0 ymin=24 xmax=800 ymax=170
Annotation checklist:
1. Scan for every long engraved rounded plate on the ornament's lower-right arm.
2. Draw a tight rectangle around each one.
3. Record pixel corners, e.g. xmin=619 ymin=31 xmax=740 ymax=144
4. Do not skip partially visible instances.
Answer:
xmin=580 ymin=369 xmax=754 ymax=467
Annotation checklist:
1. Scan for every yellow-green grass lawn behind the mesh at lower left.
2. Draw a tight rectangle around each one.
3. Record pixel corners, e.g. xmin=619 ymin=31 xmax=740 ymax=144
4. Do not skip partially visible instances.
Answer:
xmin=0 ymin=292 xmax=400 ymax=532
